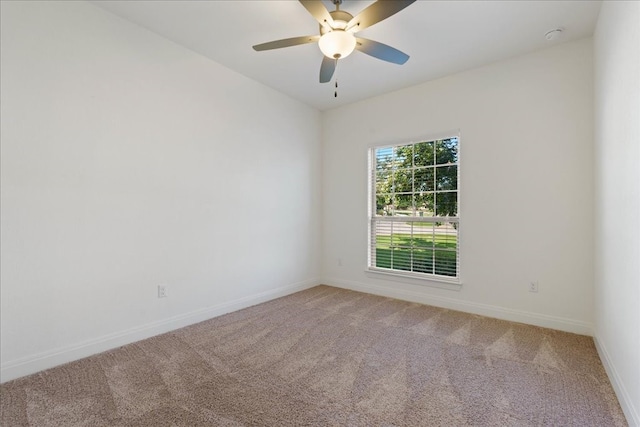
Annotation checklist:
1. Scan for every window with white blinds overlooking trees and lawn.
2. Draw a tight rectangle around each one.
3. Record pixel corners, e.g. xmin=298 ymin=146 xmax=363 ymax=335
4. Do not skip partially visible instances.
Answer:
xmin=369 ymin=136 xmax=460 ymax=283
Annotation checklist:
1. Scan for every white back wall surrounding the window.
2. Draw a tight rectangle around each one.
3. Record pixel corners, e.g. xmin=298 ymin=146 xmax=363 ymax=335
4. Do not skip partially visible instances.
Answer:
xmin=323 ymin=39 xmax=593 ymax=334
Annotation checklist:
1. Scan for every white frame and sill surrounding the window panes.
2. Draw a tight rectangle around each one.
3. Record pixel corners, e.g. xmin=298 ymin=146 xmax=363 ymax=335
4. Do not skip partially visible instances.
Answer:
xmin=366 ymin=131 xmax=462 ymax=290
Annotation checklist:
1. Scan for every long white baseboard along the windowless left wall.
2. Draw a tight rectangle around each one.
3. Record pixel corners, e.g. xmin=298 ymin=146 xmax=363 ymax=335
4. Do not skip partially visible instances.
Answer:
xmin=0 ymin=278 xmax=320 ymax=383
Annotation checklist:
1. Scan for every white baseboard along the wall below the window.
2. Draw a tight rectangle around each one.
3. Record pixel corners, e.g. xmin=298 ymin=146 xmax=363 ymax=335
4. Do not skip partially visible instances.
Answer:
xmin=323 ymin=278 xmax=593 ymax=336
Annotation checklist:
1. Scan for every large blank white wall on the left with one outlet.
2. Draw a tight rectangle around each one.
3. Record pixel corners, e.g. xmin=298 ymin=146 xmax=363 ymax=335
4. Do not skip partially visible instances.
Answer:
xmin=0 ymin=1 xmax=321 ymax=381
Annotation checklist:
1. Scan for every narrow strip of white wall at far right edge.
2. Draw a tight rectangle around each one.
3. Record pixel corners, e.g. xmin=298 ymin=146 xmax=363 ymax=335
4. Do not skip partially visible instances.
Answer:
xmin=594 ymin=1 xmax=640 ymax=426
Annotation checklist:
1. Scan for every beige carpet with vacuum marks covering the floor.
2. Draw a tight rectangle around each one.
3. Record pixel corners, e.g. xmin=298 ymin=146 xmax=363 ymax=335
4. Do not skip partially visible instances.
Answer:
xmin=0 ymin=286 xmax=626 ymax=427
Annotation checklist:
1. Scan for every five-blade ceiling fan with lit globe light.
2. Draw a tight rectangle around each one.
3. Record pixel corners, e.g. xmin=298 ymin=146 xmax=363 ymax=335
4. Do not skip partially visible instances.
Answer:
xmin=253 ymin=0 xmax=416 ymax=83
